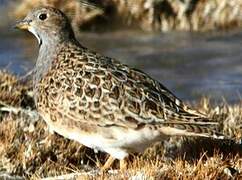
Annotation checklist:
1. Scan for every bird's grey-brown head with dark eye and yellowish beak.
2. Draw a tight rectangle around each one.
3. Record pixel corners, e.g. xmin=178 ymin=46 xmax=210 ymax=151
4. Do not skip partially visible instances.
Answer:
xmin=16 ymin=7 xmax=74 ymax=44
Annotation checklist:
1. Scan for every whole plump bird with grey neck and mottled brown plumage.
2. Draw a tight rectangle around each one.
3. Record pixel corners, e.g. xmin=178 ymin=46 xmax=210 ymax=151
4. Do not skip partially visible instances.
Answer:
xmin=15 ymin=7 xmax=223 ymax=169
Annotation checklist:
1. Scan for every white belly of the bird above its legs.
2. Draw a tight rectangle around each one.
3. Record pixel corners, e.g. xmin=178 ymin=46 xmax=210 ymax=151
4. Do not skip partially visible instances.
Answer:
xmin=54 ymin=124 xmax=167 ymax=159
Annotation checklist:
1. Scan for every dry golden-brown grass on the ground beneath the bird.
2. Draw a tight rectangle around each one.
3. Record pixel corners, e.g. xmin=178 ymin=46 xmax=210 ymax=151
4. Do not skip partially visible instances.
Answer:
xmin=0 ymin=72 xmax=242 ymax=179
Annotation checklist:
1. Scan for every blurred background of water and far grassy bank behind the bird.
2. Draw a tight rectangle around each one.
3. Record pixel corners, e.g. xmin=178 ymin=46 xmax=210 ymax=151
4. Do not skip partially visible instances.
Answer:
xmin=0 ymin=0 xmax=242 ymax=103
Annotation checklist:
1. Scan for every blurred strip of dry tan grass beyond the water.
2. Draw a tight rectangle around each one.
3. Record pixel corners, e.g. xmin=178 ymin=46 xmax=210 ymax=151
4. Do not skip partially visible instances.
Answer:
xmin=11 ymin=0 xmax=242 ymax=31
